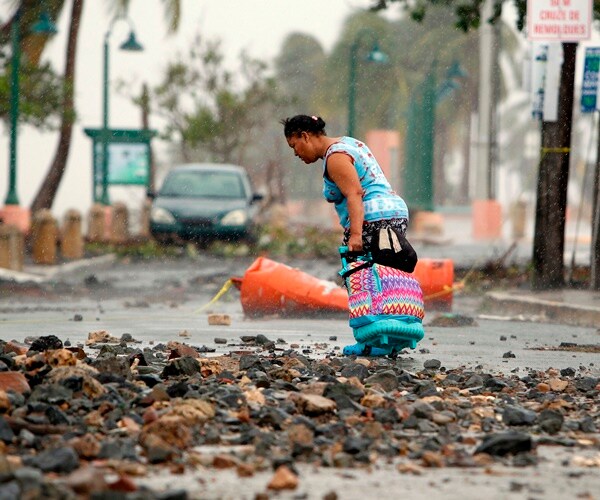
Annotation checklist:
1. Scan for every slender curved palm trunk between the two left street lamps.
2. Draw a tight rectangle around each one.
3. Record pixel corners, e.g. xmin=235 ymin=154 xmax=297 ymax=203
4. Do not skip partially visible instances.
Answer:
xmin=30 ymin=0 xmax=84 ymax=213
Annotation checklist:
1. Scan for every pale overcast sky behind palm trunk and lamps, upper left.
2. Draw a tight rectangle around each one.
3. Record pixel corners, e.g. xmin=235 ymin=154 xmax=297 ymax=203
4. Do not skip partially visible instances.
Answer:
xmin=0 ymin=0 xmax=390 ymax=217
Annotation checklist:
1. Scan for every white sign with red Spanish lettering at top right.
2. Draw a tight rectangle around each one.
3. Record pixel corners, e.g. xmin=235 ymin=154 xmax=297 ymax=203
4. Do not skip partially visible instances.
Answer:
xmin=527 ymin=0 xmax=593 ymax=42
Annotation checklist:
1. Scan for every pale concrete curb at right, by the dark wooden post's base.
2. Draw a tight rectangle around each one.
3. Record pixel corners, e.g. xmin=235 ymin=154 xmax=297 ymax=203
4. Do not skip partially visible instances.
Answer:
xmin=483 ymin=291 xmax=600 ymax=327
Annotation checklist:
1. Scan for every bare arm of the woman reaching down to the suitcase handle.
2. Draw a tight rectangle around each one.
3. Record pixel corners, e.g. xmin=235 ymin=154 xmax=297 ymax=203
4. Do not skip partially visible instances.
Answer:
xmin=327 ymin=153 xmax=364 ymax=251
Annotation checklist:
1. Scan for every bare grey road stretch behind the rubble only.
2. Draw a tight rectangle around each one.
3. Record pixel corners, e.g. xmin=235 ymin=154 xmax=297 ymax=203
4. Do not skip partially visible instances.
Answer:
xmin=0 ymin=255 xmax=600 ymax=373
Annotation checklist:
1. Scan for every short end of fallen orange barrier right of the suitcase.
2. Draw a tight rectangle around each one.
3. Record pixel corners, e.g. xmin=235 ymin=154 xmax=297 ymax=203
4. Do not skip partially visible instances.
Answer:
xmin=413 ymin=259 xmax=454 ymax=310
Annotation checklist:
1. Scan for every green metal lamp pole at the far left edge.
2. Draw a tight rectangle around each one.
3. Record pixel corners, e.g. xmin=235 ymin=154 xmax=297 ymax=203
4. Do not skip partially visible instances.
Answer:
xmin=6 ymin=8 xmax=21 ymax=205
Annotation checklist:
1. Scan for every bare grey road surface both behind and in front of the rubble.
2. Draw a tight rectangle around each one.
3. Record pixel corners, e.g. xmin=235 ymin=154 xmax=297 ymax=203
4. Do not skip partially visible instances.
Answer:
xmin=0 ymin=255 xmax=600 ymax=500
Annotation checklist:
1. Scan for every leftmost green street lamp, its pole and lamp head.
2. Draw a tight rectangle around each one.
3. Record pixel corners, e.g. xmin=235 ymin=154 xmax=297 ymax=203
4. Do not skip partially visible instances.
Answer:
xmin=5 ymin=7 xmax=57 ymax=226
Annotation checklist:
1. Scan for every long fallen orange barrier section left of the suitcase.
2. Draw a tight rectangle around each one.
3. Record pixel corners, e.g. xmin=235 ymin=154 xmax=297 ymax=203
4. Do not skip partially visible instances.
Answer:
xmin=233 ymin=257 xmax=348 ymax=316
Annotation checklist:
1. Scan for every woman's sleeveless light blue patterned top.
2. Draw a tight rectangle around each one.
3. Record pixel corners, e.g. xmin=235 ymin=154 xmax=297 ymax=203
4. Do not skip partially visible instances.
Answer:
xmin=323 ymin=137 xmax=408 ymax=228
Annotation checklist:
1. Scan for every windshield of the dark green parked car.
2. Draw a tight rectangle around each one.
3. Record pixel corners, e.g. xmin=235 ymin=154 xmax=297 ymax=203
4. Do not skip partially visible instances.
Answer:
xmin=160 ymin=171 xmax=246 ymax=198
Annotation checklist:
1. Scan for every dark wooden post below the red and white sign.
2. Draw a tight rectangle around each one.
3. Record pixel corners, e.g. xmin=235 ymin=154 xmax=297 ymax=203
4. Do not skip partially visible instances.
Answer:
xmin=532 ymin=43 xmax=577 ymax=290
